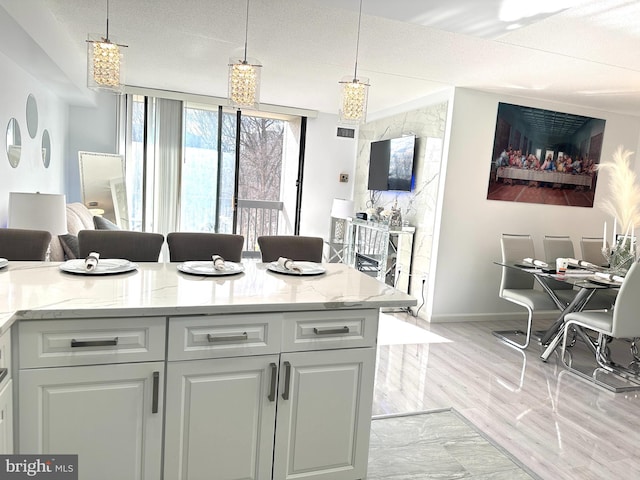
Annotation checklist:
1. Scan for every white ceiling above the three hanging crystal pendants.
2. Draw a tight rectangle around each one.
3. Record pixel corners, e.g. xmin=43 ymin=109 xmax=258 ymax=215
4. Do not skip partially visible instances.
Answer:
xmin=0 ymin=0 xmax=640 ymax=115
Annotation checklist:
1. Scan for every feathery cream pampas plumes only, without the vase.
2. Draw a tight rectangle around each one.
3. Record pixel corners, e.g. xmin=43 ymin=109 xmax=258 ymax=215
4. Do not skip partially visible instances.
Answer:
xmin=598 ymin=146 xmax=640 ymax=235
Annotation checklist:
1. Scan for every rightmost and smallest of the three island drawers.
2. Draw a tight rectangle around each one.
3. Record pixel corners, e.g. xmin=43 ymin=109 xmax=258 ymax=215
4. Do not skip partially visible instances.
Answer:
xmin=282 ymin=309 xmax=378 ymax=352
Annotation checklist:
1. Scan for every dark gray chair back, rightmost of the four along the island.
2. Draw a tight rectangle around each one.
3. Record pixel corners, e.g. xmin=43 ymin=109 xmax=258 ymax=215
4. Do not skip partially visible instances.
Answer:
xmin=258 ymin=235 xmax=324 ymax=263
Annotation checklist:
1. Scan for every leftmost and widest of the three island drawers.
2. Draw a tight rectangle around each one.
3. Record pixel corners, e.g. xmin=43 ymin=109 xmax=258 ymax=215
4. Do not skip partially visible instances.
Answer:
xmin=19 ymin=317 xmax=166 ymax=369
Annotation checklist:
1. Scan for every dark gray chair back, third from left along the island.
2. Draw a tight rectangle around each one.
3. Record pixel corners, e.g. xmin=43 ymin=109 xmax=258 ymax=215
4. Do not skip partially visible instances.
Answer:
xmin=167 ymin=232 xmax=244 ymax=262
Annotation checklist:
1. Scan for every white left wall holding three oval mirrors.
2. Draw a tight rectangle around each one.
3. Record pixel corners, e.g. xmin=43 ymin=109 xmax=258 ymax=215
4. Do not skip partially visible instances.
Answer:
xmin=0 ymin=51 xmax=68 ymax=227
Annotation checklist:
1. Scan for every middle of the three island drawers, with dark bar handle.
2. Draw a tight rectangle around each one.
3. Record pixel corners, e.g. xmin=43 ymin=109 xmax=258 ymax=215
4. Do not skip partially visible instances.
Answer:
xmin=168 ymin=313 xmax=282 ymax=360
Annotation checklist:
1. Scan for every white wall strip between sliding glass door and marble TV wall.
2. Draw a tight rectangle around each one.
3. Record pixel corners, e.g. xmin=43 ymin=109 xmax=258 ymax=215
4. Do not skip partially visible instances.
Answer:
xmin=300 ymin=113 xmax=357 ymax=237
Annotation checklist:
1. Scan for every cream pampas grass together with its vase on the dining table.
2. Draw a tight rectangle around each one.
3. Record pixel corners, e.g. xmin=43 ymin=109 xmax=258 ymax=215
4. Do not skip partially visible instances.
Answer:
xmin=598 ymin=146 xmax=640 ymax=272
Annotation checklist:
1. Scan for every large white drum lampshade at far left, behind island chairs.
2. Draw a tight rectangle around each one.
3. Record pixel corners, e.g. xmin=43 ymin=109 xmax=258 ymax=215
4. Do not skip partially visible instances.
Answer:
xmin=8 ymin=192 xmax=67 ymax=236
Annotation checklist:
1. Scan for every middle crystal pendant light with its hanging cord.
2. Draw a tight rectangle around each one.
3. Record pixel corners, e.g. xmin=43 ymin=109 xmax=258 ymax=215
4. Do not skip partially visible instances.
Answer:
xmin=229 ymin=0 xmax=262 ymax=108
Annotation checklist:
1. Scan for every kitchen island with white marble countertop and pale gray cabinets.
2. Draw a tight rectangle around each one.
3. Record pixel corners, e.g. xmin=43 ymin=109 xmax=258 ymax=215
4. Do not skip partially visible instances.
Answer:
xmin=0 ymin=262 xmax=416 ymax=480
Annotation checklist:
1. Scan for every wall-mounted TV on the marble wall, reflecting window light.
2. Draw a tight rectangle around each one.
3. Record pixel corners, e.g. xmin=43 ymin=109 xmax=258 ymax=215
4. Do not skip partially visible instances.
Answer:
xmin=367 ymin=135 xmax=416 ymax=192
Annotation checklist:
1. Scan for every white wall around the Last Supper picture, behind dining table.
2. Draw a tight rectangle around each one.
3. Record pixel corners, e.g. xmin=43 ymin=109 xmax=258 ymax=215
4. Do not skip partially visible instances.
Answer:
xmin=427 ymin=89 xmax=640 ymax=322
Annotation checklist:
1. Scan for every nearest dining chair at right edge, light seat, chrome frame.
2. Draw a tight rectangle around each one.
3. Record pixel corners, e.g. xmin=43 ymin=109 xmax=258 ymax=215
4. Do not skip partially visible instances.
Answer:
xmin=561 ymin=262 xmax=640 ymax=388
